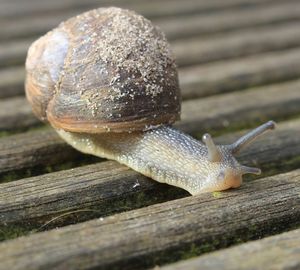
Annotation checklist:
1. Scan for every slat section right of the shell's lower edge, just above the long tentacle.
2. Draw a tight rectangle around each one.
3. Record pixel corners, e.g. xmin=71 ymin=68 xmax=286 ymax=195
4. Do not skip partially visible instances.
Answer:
xmin=177 ymin=80 xmax=300 ymax=133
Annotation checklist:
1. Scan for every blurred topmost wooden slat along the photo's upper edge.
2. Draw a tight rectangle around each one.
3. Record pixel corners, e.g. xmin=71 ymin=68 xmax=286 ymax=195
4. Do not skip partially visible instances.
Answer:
xmin=0 ymin=0 xmax=288 ymax=18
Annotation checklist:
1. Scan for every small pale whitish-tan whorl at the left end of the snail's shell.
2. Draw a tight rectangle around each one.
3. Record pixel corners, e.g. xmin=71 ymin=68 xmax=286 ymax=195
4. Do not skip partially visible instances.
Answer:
xmin=25 ymin=29 xmax=69 ymax=121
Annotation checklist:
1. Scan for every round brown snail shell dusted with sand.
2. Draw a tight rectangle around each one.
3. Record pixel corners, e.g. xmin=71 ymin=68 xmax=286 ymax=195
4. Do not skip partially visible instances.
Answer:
xmin=26 ymin=7 xmax=181 ymax=133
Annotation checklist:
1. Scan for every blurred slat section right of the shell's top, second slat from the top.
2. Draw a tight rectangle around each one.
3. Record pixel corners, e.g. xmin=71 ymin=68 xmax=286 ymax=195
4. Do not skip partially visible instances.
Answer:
xmin=159 ymin=1 xmax=300 ymax=40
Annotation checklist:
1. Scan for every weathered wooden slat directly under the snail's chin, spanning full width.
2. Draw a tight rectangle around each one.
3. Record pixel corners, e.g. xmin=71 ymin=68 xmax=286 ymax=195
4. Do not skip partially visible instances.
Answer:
xmin=0 ymin=170 xmax=300 ymax=269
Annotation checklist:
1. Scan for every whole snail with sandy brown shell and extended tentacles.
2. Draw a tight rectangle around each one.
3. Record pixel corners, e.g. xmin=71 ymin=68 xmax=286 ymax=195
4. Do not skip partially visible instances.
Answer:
xmin=25 ymin=7 xmax=275 ymax=195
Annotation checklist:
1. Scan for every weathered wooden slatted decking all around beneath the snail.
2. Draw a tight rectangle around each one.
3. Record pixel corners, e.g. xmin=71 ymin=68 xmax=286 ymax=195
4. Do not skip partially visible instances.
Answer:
xmin=0 ymin=0 xmax=300 ymax=270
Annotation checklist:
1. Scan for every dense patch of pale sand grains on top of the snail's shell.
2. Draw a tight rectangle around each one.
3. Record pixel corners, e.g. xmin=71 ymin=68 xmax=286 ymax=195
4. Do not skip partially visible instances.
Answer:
xmin=76 ymin=7 xmax=175 ymax=96
